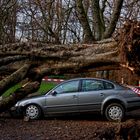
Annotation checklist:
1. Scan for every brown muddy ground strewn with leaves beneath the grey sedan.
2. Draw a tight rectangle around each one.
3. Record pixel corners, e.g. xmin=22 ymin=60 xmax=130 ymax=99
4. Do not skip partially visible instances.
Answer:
xmin=0 ymin=110 xmax=140 ymax=140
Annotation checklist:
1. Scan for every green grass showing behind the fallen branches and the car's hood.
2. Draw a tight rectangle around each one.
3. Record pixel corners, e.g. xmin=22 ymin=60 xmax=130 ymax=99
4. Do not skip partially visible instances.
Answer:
xmin=2 ymin=82 xmax=56 ymax=97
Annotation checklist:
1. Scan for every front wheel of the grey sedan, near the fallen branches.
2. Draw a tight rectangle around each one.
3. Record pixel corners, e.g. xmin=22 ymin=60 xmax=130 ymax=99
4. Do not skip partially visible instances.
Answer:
xmin=25 ymin=104 xmax=41 ymax=120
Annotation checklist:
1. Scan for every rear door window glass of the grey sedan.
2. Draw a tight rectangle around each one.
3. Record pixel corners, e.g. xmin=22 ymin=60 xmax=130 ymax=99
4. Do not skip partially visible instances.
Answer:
xmin=82 ymin=80 xmax=104 ymax=91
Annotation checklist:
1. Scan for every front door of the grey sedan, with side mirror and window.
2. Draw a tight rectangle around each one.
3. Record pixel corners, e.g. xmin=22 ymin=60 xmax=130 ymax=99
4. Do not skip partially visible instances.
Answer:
xmin=45 ymin=80 xmax=79 ymax=114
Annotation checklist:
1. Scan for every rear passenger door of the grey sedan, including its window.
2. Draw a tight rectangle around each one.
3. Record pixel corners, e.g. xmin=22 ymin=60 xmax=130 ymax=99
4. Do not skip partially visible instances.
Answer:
xmin=78 ymin=79 xmax=105 ymax=112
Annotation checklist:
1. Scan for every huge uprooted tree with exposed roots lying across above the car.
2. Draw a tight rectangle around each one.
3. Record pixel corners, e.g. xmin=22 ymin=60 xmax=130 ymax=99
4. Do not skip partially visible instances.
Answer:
xmin=0 ymin=21 xmax=140 ymax=113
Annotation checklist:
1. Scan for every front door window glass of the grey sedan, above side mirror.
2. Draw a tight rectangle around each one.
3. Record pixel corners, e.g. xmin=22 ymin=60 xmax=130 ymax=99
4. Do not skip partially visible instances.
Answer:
xmin=55 ymin=81 xmax=79 ymax=94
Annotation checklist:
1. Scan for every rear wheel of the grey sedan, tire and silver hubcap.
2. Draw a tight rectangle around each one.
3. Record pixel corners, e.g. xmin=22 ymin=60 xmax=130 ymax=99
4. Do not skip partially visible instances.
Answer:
xmin=105 ymin=103 xmax=125 ymax=121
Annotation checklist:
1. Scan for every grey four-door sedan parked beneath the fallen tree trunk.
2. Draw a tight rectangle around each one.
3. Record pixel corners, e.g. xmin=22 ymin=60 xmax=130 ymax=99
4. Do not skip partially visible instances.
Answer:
xmin=15 ymin=78 xmax=140 ymax=121
